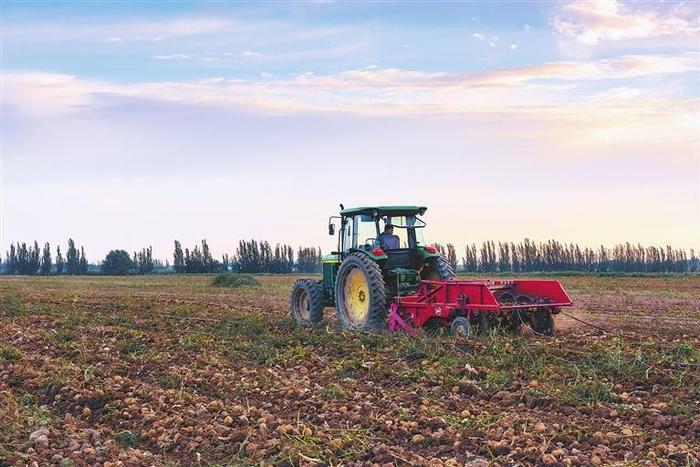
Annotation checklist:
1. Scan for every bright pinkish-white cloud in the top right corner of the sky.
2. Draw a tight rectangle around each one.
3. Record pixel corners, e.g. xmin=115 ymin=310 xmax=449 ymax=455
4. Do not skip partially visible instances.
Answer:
xmin=553 ymin=0 xmax=700 ymax=45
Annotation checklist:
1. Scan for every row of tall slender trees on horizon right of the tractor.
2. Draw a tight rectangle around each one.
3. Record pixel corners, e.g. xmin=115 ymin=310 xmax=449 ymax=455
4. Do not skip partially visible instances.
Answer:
xmin=439 ymin=238 xmax=700 ymax=273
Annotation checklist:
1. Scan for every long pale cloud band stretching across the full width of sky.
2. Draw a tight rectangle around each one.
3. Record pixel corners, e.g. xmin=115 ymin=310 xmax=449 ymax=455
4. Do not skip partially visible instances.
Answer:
xmin=2 ymin=53 xmax=700 ymax=145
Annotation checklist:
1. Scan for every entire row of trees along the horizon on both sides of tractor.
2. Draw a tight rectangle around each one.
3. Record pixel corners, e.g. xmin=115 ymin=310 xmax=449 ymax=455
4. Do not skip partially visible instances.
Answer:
xmin=0 ymin=238 xmax=700 ymax=275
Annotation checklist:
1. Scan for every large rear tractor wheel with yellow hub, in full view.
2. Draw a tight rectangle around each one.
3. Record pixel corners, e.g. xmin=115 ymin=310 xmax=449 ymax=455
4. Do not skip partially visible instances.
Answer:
xmin=335 ymin=252 xmax=388 ymax=330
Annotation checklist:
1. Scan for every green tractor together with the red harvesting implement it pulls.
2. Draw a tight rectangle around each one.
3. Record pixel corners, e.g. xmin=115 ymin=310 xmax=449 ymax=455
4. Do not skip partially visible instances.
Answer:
xmin=290 ymin=204 xmax=573 ymax=336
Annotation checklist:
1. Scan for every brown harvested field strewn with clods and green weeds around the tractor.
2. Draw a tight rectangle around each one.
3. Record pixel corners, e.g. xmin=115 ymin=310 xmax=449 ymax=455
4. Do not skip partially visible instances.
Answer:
xmin=0 ymin=276 xmax=700 ymax=465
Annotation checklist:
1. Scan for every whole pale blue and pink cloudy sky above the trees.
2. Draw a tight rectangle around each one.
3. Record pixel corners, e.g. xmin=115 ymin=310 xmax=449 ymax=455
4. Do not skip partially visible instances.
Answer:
xmin=0 ymin=0 xmax=700 ymax=261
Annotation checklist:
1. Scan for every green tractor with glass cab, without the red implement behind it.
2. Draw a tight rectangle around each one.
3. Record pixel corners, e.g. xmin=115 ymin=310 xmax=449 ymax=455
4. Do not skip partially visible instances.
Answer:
xmin=290 ymin=204 xmax=455 ymax=329
